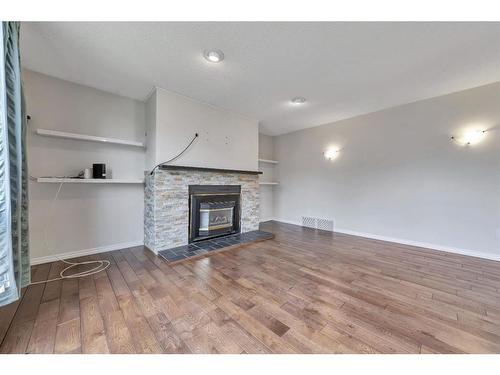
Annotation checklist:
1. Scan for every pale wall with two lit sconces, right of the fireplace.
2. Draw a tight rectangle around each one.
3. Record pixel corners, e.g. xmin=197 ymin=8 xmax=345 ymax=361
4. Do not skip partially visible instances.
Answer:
xmin=275 ymin=84 xmax=500 ymax=259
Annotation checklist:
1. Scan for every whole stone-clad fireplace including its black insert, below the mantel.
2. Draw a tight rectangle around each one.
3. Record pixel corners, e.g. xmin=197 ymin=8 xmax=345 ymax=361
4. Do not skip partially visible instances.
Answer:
xmin=144 ymin=165 xmax=260 ymax=254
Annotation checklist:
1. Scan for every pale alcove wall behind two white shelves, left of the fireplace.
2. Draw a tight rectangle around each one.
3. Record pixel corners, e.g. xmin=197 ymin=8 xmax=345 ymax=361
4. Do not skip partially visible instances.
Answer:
xmin=23 ymin=71 xmax=145 ymax=262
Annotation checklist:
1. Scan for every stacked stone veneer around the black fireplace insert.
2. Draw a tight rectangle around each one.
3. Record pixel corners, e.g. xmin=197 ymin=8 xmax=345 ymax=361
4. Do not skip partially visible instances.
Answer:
xmin=144 ymin=170 xmax=260 ymax=253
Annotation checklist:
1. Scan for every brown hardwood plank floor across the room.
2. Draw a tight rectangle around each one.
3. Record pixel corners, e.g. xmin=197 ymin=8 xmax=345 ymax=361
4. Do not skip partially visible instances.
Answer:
xmin=0 ymin=222 xmax=500 ymax=353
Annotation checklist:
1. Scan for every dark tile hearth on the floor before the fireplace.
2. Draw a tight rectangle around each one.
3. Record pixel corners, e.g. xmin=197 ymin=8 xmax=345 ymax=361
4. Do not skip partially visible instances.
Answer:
xmin=158 ymin=230 xmax=274 ymax=263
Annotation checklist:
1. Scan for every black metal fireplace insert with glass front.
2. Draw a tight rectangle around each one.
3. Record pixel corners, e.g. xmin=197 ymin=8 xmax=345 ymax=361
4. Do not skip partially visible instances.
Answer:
xmin=189 ymin=185 xmax=241 ymax=243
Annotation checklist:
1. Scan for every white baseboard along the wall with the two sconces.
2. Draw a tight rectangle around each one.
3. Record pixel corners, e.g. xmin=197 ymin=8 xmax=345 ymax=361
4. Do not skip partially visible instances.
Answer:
xmin=272 ymin=218 xmax=500 ymax=261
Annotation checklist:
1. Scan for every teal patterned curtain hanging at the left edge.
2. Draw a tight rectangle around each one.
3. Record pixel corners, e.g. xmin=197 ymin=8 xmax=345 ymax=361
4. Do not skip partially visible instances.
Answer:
xmin=0 ymin=22 xmax=30 ymax=306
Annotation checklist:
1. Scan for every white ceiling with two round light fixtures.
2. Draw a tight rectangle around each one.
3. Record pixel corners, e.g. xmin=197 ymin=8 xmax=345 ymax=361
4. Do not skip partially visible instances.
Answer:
xmin=21 ymin=22 xmax=500 ymax=135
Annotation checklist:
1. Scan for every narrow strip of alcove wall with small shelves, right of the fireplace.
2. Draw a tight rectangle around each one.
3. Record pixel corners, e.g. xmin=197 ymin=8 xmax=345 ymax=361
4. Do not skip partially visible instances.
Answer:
xmin=259 ymin=134 xmax=279 ymax=221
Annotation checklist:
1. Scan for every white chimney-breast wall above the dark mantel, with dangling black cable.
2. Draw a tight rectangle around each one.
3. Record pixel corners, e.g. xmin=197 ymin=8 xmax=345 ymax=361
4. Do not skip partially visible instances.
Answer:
xmin=146 ymin=88 xmax=259 ymax=170
